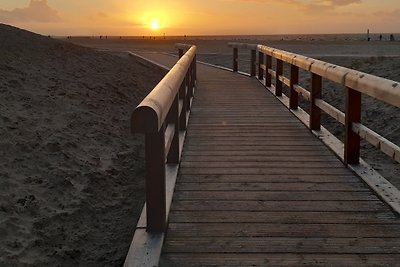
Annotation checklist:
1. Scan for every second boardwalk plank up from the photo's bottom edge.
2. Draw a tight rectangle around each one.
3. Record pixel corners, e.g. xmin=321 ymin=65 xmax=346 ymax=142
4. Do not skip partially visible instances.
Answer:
xmin=164 ymin=237 xmax=400 ymax=254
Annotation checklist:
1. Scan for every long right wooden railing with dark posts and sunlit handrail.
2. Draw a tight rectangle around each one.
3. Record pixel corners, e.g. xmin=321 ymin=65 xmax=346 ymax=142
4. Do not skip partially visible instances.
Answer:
xmin=229 ymin=43 xmax=400 ymax=164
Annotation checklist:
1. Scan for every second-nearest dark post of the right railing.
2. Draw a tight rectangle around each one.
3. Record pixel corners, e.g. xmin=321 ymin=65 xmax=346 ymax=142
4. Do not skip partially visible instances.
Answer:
xmin=310 ymin=73 xmax=322 ymax=130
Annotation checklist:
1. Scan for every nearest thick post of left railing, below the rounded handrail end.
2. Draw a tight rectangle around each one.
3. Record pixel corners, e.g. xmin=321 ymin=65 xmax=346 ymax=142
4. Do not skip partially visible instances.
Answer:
xmin=145 ymin=125 xmax=166 ymax=232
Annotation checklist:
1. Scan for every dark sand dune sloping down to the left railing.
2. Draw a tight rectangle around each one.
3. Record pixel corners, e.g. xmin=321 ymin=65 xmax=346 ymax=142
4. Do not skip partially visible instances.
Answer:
xmin=0 ymin=24 xmax=165 ymax=266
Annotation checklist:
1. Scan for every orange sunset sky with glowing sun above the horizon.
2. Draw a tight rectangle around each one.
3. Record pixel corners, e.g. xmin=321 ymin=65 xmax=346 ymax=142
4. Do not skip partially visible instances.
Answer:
xmin=0 ymin=0 xmax=400 ymax=36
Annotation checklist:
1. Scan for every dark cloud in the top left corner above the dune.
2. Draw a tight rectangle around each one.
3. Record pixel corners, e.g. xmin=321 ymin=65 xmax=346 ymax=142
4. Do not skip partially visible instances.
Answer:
xmin=0 ymin=0 xmax=61 ymax=23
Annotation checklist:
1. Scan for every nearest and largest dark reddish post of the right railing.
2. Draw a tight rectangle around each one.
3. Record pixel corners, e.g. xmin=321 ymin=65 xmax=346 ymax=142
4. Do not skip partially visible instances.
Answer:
xmin=344 ymin=87 xmax=361 ymax=164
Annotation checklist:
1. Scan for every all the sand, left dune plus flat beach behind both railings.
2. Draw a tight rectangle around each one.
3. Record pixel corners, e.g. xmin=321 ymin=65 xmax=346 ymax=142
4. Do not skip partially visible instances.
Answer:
xmin=0 ymin=24 xmax=400 ymax=266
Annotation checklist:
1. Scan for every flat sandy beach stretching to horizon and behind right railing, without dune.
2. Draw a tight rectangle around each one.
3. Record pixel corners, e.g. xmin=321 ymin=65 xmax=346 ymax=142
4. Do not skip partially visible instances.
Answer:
xmin=71 ymin=35 xmax=400 ymax=188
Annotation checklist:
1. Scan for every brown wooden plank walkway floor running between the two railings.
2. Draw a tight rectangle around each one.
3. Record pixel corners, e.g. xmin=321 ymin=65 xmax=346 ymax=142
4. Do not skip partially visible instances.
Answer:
xmin=135 ymin=55 xmax=400 ymax=266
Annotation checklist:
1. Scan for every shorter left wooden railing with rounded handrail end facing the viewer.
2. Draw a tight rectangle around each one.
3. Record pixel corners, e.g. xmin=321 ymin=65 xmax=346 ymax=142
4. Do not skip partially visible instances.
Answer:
xmin=132 ymin=45 xmax=197 ymax=232
